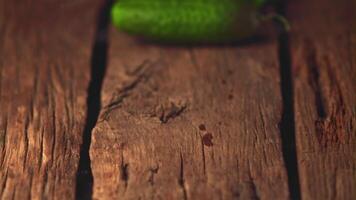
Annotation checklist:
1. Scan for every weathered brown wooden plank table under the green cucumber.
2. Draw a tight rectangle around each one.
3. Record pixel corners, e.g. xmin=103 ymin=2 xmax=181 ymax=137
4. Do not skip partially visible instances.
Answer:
xmin=0 ymin=0 xmax=356 ymax=200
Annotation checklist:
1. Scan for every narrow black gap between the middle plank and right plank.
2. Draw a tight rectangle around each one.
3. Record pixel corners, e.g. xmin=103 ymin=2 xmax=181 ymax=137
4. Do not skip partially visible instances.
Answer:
xmin=276 ymin=1 xmax=301 ymax=199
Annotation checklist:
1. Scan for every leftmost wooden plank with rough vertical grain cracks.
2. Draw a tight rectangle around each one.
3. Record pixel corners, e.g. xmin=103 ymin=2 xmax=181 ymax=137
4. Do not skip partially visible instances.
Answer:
xmin=0 ymin=0 xmax=99 ymax=199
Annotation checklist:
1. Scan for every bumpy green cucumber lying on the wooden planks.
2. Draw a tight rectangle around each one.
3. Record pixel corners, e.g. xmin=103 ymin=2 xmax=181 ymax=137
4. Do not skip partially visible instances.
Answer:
xmin=111 ymin=0 xmax=265 ymax=43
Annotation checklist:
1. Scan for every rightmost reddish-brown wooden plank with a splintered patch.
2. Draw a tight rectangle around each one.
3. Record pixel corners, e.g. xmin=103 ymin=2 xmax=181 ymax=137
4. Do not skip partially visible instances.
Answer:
xmin=288 ymin=0 xmax=356 ymax=199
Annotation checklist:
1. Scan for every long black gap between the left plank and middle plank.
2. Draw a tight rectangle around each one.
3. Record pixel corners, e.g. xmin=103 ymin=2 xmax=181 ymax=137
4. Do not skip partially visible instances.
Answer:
xmin=76 ymin=0 xmax=113 ymax=199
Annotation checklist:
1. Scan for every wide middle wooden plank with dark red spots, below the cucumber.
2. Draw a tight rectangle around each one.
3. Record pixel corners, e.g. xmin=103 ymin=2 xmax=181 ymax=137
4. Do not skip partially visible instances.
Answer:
xmin=90 ymin=30 xmax=289 ymax=199
